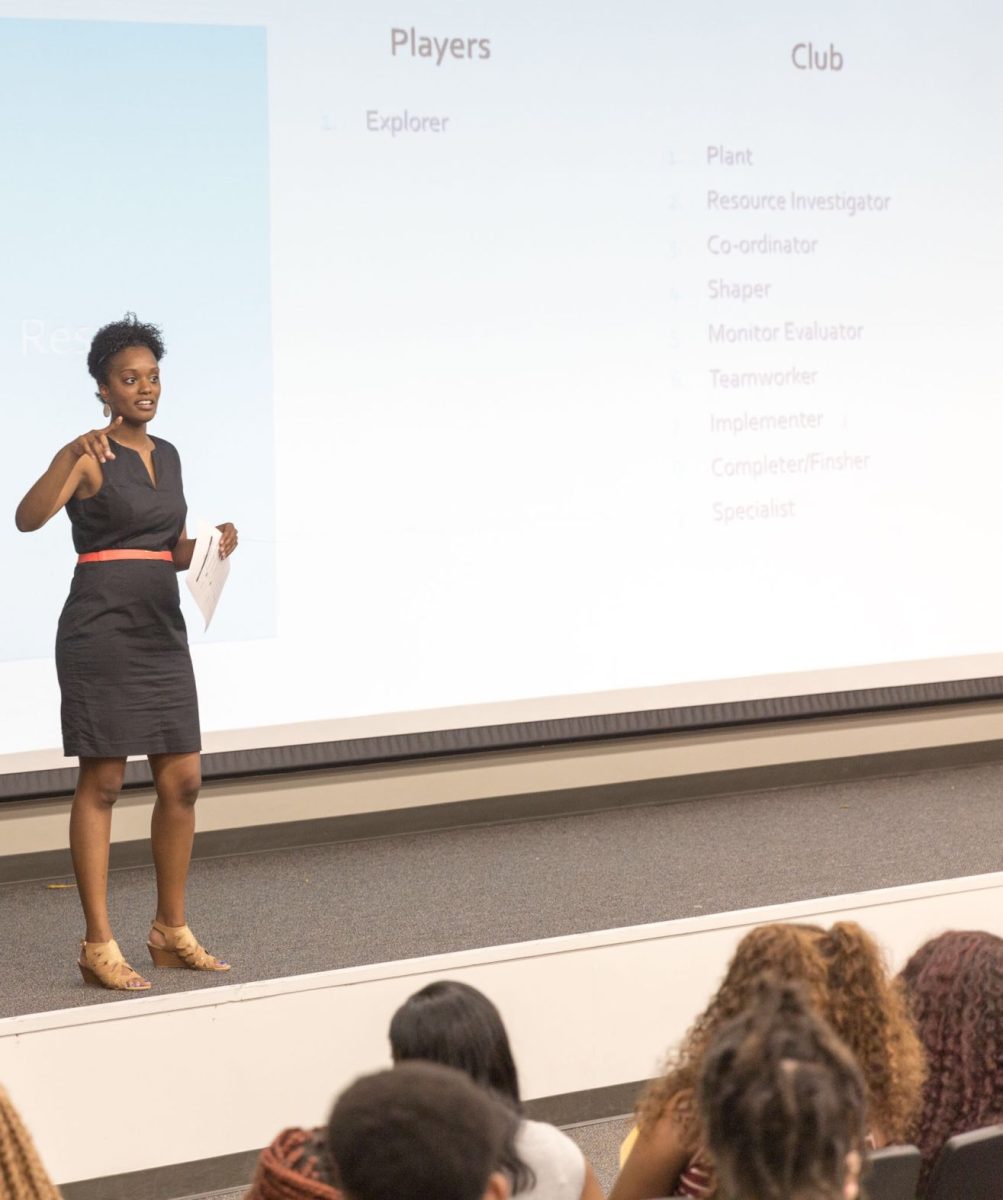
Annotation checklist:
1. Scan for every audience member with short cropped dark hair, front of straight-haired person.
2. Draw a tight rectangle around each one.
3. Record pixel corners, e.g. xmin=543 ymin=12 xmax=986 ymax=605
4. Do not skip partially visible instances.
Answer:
xmin=328 ymin=1062 xmax=517 ymax=1200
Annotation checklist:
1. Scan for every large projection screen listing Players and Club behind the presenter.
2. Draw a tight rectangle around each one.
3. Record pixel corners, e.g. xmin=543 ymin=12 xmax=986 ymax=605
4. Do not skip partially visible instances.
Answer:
xmin=0 ymin=0 xmax=1003 ymax=769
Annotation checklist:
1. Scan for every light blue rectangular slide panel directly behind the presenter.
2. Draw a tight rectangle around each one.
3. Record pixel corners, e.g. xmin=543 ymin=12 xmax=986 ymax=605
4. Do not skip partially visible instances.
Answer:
xmin=0 ymin=10 xmax=276 ymax=660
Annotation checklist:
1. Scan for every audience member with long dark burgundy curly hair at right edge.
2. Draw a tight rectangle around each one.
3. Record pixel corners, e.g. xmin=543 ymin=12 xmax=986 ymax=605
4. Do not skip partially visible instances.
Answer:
xmin=900 ymin=931 xmax=1003 ymax=1189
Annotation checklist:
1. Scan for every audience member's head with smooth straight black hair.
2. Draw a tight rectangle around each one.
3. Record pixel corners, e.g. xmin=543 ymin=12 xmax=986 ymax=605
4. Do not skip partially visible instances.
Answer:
xmin=390 ymin=979 xmax=521 ymax=1110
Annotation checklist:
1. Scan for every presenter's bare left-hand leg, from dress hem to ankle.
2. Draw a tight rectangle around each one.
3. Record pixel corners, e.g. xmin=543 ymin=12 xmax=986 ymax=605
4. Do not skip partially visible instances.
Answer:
xmin=70 ymin=758 xmax=125 ymax=942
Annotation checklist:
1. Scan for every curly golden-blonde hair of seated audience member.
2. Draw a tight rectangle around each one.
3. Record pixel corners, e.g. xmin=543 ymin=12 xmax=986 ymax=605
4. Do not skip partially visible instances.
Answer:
xmin=637 ymin=922 xmax=923 ymax=1141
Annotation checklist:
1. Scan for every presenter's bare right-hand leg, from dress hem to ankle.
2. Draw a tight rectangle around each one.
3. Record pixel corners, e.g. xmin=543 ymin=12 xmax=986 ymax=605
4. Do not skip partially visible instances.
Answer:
xmin=150 ymin=752 xmax=202 ymax=926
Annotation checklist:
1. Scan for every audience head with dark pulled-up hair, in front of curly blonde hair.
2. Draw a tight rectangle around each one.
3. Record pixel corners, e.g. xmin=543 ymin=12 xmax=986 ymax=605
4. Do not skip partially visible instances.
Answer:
xmin=698 ymin=984 xmax=866 ymax=1200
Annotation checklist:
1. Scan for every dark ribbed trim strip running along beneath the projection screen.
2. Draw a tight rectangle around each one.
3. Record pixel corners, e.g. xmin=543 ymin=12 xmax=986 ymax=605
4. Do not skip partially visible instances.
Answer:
xmin=0 ymin=676 xmax=1003 ymax=802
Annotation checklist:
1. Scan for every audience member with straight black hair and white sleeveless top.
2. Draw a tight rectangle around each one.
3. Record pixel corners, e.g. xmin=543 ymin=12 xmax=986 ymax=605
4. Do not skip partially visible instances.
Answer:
xmin=390 ymin=979 xmax=602 ymax=1200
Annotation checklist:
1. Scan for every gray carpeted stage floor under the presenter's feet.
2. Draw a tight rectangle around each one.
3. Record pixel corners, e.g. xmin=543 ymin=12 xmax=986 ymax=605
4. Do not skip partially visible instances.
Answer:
xmin=0 ymin=764 xmax=1003 ymax=1016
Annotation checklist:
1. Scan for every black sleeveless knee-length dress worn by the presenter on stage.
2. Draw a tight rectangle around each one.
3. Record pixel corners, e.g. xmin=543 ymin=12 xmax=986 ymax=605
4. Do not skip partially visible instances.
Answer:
xmin=55 ymin=438 xmax=200 ymax=758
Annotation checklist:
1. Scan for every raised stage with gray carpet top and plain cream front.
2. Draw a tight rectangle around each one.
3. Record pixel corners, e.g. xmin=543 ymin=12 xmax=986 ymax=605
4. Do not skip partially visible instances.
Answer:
xmin=0 ymin=766 xmax=1003 ymax=1200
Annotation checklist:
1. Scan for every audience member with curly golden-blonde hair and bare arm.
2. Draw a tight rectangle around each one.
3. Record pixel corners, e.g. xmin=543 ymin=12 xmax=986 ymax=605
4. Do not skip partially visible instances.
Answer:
xmin=609 ymin=922 xmax=923 ymax=1200
